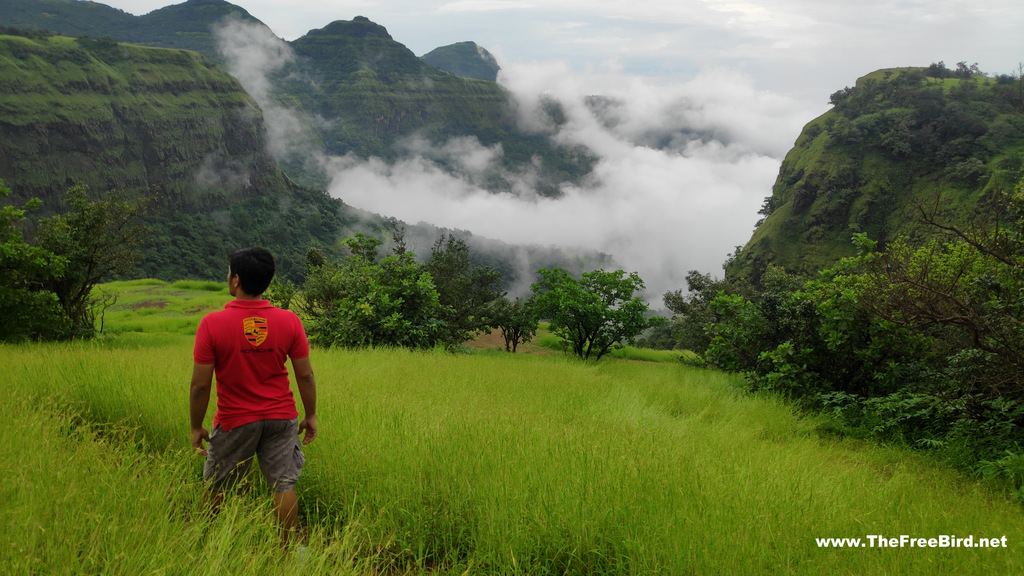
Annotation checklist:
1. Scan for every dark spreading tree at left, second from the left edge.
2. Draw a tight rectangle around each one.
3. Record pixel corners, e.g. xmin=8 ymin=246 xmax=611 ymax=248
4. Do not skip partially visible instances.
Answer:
xmin=37 ymin=184 xmax=150 ymax=336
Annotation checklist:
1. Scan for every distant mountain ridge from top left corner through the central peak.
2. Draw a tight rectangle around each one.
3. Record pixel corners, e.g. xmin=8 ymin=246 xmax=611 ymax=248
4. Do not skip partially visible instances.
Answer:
xmin=0 ymin=0 xmax=596 ymax=197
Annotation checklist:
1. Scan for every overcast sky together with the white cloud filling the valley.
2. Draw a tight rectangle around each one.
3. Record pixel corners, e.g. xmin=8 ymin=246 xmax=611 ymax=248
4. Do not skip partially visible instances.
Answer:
xmin=97 ymin=0 xmax=1024 ymax=299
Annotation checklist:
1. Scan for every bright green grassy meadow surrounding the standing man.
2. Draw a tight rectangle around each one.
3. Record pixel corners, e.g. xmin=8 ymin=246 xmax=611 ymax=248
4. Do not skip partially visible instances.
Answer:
xmin=0 ymin=281 xmax=1024 ymax=575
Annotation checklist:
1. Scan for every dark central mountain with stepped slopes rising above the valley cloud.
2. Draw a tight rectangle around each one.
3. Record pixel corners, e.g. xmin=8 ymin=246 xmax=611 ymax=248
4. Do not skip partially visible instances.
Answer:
xmin=256 ymin=16 xmax=596 ymax=196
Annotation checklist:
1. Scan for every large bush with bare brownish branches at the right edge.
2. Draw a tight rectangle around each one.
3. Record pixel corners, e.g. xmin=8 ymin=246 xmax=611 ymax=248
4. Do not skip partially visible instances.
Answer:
xmin=864 ymin=184 xmax=1024 ymax=402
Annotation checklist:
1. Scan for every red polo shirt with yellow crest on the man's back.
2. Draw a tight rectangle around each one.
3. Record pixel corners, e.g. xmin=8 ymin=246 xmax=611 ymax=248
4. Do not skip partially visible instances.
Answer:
xmin=193 ymin=299 xmax=309 ymax=430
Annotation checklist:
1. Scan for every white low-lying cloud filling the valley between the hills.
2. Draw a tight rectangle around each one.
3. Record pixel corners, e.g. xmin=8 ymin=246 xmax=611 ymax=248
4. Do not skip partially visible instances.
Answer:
xmin=221 ymin=23 xmax=811 ymax=305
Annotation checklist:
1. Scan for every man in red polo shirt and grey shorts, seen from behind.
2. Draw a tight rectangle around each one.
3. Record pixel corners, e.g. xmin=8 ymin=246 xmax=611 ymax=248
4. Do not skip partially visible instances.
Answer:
xmin=189 ymin=248 xmax=316 ymax=539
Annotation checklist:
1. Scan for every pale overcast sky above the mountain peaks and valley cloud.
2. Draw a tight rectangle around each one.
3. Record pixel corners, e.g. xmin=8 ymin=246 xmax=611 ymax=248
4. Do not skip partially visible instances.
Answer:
xmin=94 ymin=0 xmax=1024 ymax=101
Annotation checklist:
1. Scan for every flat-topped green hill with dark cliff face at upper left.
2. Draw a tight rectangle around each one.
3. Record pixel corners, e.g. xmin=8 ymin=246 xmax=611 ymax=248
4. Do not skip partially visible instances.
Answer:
xmin=0 ymin=31 xmax=284 ymax=204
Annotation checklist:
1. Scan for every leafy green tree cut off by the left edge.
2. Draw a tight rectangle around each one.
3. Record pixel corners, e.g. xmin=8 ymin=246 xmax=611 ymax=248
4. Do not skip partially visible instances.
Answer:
xmin=0 ymin=180 xmax=68 ymax=341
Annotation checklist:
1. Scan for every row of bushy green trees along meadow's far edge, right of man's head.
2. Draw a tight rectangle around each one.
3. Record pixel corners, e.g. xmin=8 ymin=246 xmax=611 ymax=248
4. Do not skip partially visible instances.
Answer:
xmin=267 ymin=225 xmax=658 ymax=360
